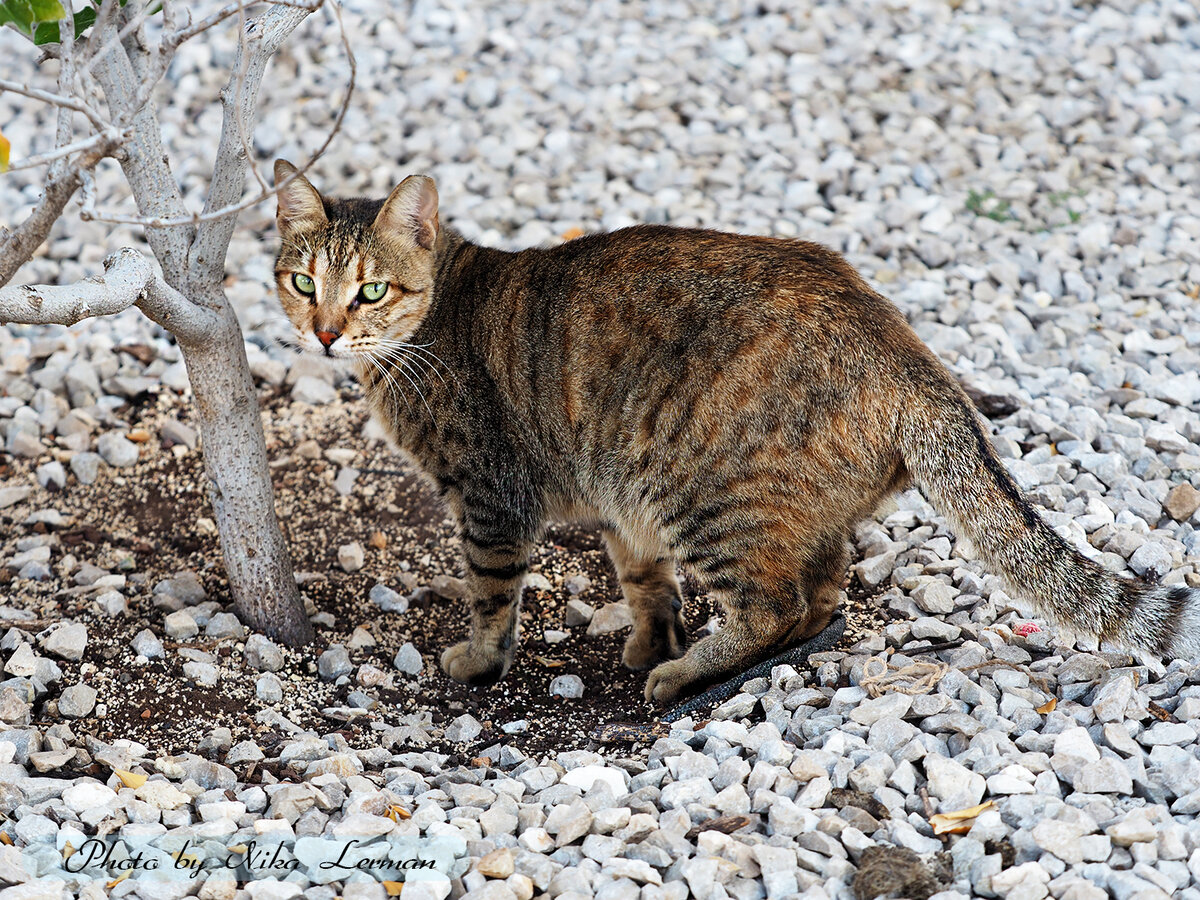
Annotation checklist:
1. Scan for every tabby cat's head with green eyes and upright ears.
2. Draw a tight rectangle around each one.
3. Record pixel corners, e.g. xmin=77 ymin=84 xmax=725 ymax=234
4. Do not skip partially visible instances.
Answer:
xmin=275 ymin=160 xmax=438 ymax=359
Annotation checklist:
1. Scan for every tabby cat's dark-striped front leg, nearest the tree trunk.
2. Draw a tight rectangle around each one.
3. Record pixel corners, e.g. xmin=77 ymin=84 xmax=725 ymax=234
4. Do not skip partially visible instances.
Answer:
xmin=442 ymin=530 xmax=532 ymax=685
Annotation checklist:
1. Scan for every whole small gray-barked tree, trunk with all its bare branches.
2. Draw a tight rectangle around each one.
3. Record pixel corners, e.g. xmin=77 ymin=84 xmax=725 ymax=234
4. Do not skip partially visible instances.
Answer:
xmin=0 ymin=0 xmax=324 ymax=644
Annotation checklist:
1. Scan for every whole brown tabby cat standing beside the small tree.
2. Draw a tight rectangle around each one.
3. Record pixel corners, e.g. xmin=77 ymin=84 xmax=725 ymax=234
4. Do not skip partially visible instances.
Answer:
xmin=275 ymin=160 xmax=1200 ymax=703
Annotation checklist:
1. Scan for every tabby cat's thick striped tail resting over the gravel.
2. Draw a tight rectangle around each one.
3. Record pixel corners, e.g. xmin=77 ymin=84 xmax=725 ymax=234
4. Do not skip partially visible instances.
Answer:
xmin=899 ymin=376 xmax=1200 ymax=659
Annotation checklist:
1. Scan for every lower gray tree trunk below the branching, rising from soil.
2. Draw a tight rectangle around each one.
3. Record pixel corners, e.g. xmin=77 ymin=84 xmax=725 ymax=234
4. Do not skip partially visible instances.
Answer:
xmin=179 ymin=302 xmax=313 ymax=646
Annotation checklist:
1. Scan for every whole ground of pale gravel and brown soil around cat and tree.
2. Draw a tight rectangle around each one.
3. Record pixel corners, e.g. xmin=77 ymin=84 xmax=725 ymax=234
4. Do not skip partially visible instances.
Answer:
xmin=0 ymin=0 xmax=1200 ymax=900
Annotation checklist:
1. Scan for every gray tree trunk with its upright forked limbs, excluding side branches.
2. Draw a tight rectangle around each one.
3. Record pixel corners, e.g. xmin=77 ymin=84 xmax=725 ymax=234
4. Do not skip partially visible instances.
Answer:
xmin=60 ymin=6 xmax=313 ymax=644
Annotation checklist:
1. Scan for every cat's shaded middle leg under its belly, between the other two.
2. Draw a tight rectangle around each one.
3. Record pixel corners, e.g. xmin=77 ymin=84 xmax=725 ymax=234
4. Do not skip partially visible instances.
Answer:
xmin=604 ymin=529 xmax=688 ymax=670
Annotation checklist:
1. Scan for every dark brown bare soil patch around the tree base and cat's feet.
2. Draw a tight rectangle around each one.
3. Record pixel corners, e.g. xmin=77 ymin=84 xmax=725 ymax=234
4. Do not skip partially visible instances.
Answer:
xmin=0 ymin=386 xmax=881 ymax=758
